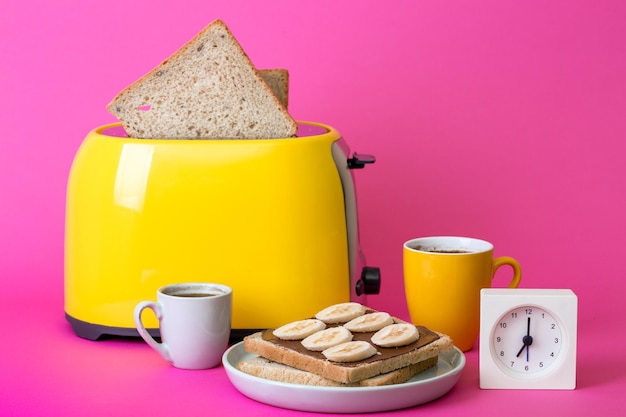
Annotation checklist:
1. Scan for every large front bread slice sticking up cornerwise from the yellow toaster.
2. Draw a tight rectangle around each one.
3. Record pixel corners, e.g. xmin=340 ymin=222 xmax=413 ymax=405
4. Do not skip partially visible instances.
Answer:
xmin=107 ymin=20 xmax=297 ymax=139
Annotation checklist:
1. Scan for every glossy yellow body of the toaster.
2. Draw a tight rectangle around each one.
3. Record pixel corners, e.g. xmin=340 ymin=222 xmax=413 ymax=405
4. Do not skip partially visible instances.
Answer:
xmin=65 ymin=122 xmax=350 ymax=329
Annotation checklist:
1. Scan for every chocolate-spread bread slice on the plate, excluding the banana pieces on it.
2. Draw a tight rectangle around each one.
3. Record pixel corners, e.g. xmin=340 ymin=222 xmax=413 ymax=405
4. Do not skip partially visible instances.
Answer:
xmin=244 ymin=309 xmax=453 ymax=384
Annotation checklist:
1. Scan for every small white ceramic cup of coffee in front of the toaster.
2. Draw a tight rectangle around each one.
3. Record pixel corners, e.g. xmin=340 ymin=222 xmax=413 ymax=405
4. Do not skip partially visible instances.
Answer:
xmin=134 ymin=283 xmax=233 ymax=369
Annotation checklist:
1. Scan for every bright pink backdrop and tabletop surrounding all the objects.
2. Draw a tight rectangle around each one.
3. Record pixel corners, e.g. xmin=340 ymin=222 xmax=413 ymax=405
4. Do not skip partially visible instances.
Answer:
xmin=0 ymin=0 xmax=626 ymax=416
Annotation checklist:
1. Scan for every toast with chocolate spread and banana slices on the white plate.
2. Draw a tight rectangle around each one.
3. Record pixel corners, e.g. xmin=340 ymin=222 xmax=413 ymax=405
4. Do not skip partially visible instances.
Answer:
xmin=239 ymin=303 xmax=453 ymax=385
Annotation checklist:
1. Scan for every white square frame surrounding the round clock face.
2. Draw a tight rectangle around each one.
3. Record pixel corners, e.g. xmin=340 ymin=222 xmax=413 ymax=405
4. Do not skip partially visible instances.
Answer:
xmin=479 ymin=288 xmax=578 ymax=389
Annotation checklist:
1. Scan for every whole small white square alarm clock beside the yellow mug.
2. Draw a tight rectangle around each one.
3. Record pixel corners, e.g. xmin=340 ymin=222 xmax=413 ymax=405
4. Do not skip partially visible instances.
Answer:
xmin=479 ymin=288 xmax=578 ymax=389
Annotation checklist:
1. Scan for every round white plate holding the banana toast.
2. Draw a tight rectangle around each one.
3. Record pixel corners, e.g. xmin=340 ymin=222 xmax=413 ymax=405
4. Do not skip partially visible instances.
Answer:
xmin=222 ymin=342 xmax=465 ymax=413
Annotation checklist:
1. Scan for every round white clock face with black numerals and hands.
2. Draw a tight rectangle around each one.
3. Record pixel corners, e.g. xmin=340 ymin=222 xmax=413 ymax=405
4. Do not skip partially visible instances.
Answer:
xmin=491 ymin=305 xmax=563 ymax=375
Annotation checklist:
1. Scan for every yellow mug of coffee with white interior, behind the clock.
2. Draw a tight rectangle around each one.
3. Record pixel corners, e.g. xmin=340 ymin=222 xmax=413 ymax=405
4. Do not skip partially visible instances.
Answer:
xmin=403 ymin=236 xmax=522 ymax=352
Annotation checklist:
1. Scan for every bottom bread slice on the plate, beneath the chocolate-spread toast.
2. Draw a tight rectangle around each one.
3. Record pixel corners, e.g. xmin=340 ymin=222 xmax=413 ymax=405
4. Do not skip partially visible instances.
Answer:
xmin=237 ymin=356 xmax=438 ymax=387
